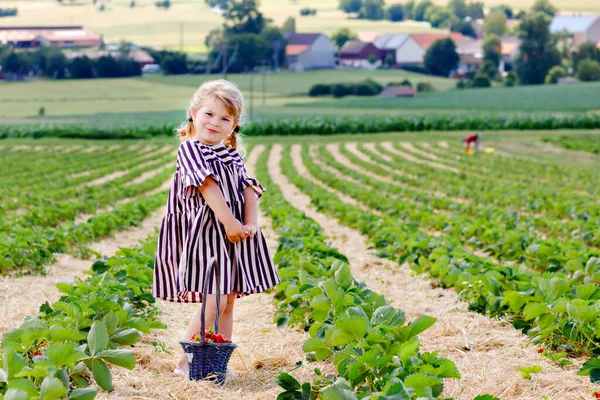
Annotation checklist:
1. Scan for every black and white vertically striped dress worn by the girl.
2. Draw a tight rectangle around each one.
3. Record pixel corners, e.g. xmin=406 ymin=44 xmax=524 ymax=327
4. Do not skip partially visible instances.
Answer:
xmin=152 ymin=139 xmax=279 ymax=303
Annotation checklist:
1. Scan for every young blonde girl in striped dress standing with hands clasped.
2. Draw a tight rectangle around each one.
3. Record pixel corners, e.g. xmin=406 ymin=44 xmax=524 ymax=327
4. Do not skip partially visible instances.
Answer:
xmin=153 ymin=80 xmax=279 ymax=375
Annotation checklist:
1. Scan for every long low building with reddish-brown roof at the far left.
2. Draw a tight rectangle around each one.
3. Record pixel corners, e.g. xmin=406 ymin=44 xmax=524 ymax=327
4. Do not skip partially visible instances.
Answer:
xmin=0 ymin=26 xmax=102 ymax=49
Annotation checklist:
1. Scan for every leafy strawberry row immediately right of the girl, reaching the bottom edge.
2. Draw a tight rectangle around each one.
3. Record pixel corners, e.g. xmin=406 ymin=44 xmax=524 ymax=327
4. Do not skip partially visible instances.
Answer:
xmin=253 ymin=146 xmax=460 ymax=400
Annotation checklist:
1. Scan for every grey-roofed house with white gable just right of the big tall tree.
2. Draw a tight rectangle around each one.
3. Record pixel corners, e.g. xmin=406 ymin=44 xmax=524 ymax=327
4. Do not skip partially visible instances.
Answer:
xmin=285 ymin=33 xmax=335 ymax=72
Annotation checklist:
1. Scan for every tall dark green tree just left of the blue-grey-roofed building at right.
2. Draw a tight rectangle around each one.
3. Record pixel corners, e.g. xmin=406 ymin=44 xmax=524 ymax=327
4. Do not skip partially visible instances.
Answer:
xmin=515 ymin=12 xmax=560 ymax=85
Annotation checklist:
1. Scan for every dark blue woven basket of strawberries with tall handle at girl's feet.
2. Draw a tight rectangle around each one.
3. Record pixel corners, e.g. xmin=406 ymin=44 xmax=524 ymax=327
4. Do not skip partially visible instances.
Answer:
xmin=179 ymin=258 xmax=237 ymax=385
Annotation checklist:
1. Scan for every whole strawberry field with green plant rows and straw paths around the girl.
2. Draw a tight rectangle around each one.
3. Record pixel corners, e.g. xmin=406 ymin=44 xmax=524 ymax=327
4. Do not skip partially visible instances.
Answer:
xmin=0 ymin=131 xmax=600 ymax=400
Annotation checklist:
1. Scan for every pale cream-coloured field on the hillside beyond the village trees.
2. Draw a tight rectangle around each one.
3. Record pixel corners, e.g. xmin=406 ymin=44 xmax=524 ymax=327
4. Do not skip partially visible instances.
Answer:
xmin=2 ymin=0 xmax=600 ymax=53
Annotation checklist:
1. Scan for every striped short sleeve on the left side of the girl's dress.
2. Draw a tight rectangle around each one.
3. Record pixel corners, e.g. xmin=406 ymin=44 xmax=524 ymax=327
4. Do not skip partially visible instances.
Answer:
xmin=177 ymin=140 xmax=219 ymax=197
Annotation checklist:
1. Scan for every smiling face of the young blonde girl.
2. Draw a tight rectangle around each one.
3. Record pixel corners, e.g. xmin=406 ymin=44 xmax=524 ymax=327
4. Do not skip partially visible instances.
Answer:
xmin=193 ymin=99 xmax=236 ymax=146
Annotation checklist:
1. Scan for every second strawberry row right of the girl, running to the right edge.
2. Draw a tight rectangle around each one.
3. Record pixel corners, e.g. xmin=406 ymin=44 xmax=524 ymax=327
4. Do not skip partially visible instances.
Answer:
xmin=282 ymin=145 xmax=600 ymax=360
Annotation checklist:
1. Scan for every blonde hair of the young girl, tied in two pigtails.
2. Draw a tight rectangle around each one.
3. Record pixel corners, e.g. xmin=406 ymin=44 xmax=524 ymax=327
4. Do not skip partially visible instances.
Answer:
xmin=176 ymin=79 xmax=245 ymax=156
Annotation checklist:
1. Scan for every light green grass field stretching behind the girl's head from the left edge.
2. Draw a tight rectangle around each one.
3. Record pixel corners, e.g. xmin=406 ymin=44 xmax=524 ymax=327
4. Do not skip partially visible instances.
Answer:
xmin=0 ymin=70 xmax=454 ymax=117
